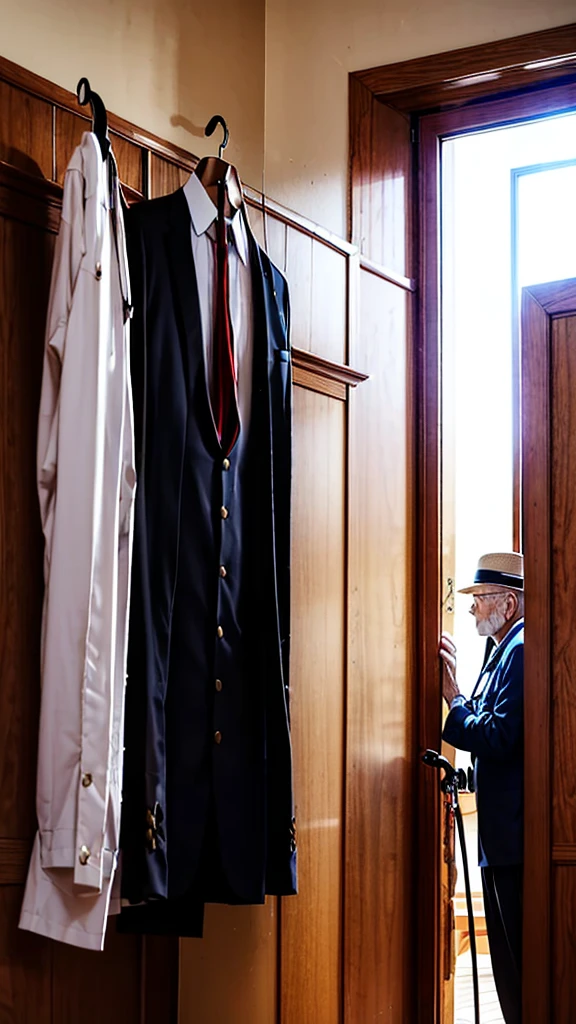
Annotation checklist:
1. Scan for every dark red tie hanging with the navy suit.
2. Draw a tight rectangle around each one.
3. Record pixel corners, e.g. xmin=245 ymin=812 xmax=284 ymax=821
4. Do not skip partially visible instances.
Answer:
xmin=211 ymin=181 xmax=240 ymax=455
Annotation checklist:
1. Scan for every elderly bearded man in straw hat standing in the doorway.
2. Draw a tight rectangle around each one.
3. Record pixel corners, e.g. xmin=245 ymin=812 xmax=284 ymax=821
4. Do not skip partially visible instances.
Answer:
xmin=440 ymin=552 xmax=524 ymax=1024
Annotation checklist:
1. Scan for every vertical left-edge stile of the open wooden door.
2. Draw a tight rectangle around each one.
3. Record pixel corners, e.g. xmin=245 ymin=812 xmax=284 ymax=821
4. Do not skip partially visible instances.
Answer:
xmin=522 ymin=290 xmax=552 ymax=1024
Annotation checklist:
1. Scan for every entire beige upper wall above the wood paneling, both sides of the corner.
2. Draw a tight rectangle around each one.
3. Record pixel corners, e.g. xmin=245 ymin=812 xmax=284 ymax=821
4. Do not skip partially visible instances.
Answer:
xmin=0 ymin=0 xmax=576 ymax=234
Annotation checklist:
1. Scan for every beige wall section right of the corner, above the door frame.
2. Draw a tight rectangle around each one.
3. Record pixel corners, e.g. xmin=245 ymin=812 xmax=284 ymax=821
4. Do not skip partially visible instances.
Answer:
xmin=264 ymin=0 xmax=576 ymax=234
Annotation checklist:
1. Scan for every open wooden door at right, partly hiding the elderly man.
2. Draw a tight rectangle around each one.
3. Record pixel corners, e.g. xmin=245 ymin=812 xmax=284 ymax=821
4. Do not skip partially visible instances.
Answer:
xmin=522 ymin=279 xmax=576 ymax=1024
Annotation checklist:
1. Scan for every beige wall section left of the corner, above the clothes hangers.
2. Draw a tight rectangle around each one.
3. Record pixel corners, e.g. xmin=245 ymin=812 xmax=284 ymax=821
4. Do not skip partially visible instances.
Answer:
xmin=0 ymin=0 xmax=265 ymax=188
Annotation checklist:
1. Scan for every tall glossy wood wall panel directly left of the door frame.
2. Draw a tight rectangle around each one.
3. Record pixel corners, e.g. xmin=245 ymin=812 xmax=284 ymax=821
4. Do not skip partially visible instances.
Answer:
xmin=344 ymin=272 xmax=409 ymax=1024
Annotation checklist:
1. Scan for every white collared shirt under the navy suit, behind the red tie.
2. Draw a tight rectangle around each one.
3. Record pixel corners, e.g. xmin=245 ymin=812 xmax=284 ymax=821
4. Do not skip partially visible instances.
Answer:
xmin=183 ymin=174 xmax=254 ymax=438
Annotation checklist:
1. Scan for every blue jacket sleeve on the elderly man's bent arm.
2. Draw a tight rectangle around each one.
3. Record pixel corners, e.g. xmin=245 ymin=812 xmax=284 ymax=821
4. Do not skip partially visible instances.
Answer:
xmin=443 ymin=645 xmax=524 ymax=759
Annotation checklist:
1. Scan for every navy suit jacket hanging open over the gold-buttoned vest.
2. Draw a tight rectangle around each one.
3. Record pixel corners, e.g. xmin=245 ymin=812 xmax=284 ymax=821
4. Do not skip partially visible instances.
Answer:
xmin=122 ymin=188 xmax=296 ymax=903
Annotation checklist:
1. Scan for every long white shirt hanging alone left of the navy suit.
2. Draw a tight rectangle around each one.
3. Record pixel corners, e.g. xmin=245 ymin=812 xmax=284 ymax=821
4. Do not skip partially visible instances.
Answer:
xmin=20 ymin=132 xmax=135 ymax=949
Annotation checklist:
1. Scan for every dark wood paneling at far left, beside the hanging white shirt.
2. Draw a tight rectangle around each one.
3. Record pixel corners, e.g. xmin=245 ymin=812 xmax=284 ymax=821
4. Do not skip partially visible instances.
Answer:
xmin=0 ymin=176 xmax=53 ymax=1024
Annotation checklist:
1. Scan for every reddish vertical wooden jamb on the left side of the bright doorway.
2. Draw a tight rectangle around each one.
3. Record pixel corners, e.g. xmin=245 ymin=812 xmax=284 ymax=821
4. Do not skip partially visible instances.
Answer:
xmin=414 ymin=108 xmax=443 ymax=1024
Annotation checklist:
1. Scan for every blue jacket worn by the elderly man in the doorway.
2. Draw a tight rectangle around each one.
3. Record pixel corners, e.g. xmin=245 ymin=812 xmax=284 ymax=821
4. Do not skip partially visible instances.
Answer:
xmin=443 ymin=620 xmax=524 ymax=867
